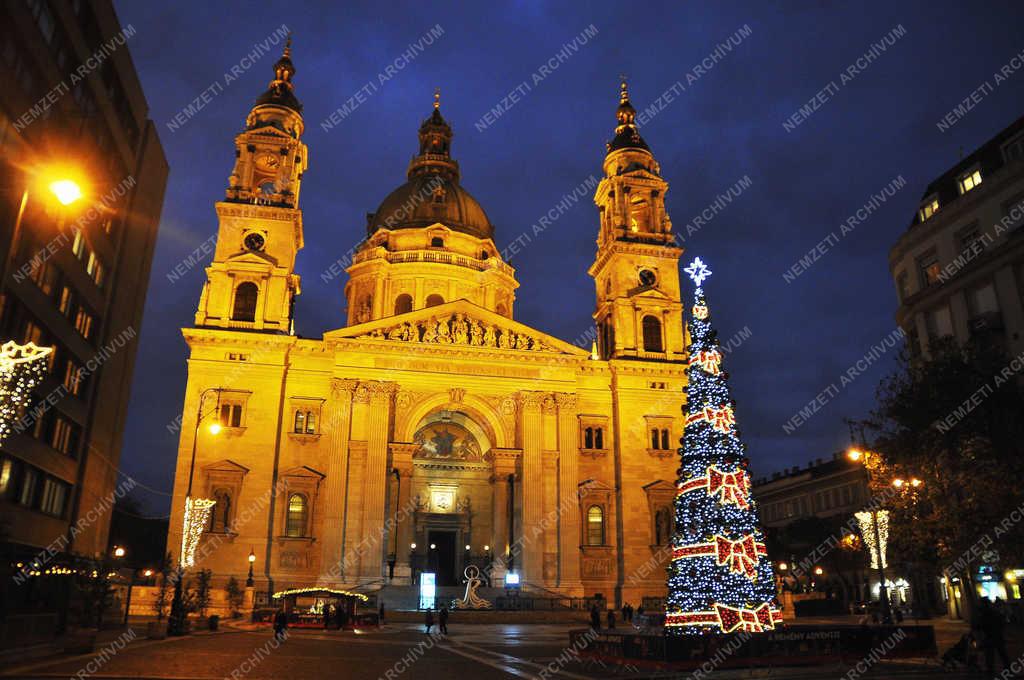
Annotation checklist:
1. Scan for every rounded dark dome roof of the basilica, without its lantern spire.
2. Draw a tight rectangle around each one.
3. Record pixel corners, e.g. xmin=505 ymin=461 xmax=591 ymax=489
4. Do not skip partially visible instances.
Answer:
xmin=367 ymin=173 xmax=495 ymax=239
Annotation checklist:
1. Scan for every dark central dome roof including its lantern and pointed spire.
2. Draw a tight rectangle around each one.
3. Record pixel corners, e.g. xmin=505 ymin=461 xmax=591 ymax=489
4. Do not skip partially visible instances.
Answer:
xmin=367 ymin=95 xmax=495 ymax=239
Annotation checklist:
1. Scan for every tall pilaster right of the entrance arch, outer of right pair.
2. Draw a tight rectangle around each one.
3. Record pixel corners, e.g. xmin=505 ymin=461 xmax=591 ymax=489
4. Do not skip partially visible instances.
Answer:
xmin=555 ymin=393 xmax=583 ymax=595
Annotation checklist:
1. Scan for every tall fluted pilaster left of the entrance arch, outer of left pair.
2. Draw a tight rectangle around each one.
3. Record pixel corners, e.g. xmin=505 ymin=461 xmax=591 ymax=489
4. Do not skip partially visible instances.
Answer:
xmin=318 ymin=378 xmax=356 ymax=586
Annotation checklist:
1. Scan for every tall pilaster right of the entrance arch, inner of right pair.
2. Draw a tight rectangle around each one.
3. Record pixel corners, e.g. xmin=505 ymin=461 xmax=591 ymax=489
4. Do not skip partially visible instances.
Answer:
xmin=515 ymin=392 xmax=547 ymax=586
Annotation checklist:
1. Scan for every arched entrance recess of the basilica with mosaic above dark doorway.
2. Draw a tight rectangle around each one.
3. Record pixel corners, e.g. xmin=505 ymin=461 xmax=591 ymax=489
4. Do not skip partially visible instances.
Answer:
xmin=411 ymin=410 xmax=495 ymax=586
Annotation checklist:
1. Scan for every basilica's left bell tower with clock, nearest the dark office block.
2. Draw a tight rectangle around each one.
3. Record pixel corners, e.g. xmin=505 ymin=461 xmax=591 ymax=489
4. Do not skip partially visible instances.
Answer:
xmin=196 ymin=37 xmax=308 ymax=333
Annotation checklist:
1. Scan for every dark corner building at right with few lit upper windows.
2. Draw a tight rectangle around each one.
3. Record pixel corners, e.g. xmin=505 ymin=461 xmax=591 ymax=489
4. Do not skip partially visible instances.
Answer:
xmin=889 ymin=118 xmax=1024 ymax=355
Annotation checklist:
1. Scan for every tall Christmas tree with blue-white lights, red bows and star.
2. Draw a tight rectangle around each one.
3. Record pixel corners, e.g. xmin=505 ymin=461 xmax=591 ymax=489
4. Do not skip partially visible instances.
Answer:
xmin=665 ymin=258 xmax=782 ymax=635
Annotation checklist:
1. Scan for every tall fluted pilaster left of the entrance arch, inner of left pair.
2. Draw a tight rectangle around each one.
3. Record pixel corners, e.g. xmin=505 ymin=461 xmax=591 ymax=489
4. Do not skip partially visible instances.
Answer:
xmin=356 ymin=381 xmax=395 ymax=583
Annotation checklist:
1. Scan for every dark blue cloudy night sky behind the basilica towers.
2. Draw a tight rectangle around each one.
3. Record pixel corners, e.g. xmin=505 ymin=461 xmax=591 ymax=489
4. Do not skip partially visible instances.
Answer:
xmin=110 ymin=1 xmax=1024 ymax=513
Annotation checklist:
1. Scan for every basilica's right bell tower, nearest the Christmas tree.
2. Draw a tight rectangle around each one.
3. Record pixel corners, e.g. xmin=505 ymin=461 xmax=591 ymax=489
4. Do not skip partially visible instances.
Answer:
xmin=588 ymin=82 xmax=685 ymax=360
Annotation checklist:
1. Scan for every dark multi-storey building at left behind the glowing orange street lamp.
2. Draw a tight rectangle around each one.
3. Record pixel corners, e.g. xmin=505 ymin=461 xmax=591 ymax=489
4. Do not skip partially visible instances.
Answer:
xmin=0 ymin=0 xmax=168 ymax=630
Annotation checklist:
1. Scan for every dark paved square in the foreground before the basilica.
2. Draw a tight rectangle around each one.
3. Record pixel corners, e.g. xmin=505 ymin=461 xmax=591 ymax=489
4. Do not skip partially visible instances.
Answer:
xmin=0 ymin=624 xmax=1015 ymax=680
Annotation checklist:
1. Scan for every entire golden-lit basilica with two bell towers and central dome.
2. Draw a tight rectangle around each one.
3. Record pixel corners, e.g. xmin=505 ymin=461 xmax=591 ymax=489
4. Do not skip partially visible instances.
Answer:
xmin=168 ymin=43 xmax=686 ymax=604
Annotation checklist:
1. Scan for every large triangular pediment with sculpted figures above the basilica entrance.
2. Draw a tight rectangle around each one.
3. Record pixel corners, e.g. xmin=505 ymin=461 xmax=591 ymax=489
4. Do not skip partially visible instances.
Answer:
xmin=324 ymin=299 xmax=589 ymax=356
